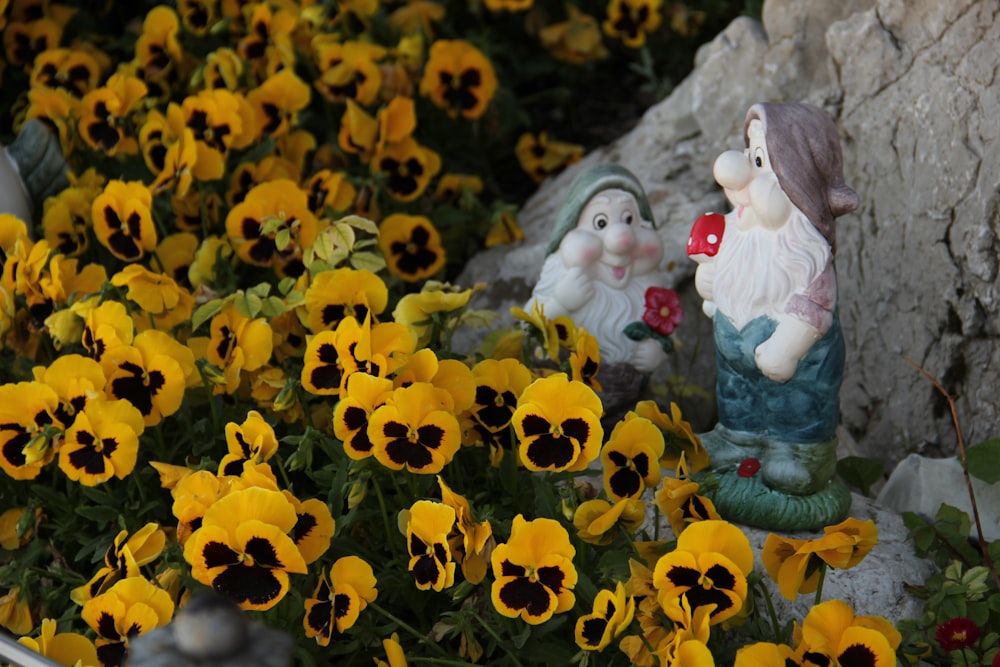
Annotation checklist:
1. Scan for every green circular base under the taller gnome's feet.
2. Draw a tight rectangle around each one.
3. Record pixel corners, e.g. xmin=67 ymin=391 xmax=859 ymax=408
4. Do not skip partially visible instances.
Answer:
xmin=706 ymin=470 xmax=851 ymax=532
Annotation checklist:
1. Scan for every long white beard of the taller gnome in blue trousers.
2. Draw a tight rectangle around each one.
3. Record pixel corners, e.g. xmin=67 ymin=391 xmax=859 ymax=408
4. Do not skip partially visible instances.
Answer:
xmin=713 ymin=211 xmax=831 ymax=330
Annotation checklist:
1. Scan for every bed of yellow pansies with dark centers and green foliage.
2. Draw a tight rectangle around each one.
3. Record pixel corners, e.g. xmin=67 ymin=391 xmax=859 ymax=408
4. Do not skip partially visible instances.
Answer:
xmin=0 ymin=0 xmax=996 ymax=667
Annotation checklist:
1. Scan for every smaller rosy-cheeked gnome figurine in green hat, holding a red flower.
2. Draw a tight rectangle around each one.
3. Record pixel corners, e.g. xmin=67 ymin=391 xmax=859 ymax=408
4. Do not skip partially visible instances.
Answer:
xmin=527 ymin=163 xmax=679 ymax=419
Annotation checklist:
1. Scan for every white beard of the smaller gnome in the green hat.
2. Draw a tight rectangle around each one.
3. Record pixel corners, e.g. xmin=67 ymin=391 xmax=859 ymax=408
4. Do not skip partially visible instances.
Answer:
xmin=528 ymin=252 xmax=658 ymax=364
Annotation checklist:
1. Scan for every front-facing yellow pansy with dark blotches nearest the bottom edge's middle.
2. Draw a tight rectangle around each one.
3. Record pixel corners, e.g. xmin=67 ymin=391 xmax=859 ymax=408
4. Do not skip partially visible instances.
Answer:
xmin=490 ymin=514 xmax=578 ymax=625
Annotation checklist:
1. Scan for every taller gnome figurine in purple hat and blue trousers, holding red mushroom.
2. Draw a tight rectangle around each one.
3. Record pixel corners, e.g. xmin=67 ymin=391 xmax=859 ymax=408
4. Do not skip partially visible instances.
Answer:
xmin=689 ymin=103 xmax=858 ymax=530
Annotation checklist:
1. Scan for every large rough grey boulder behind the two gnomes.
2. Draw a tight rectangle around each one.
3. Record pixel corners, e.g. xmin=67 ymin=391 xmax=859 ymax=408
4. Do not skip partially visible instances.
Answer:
xmin=459 ymin=0 xmax=1000 ymax=469
